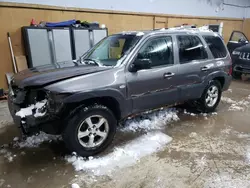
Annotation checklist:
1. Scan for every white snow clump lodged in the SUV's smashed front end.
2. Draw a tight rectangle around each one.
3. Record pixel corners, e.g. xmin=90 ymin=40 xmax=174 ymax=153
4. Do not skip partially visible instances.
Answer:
xmin=16 ymin=100 xmax=47 ymax=118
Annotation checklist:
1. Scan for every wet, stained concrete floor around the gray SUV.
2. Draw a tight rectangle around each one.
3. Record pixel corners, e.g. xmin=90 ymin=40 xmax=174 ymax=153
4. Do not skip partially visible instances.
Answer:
xmin=0 ymin=80 xmax=250 ymax=188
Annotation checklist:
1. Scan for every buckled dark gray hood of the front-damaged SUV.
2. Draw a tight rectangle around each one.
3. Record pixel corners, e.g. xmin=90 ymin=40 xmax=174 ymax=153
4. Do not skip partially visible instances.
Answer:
xmin=12 ymin=61 xmax=111 ymax=88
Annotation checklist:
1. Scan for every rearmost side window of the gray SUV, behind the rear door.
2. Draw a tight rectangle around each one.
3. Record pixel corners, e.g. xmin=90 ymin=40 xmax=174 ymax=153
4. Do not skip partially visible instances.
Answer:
xmin=203 ymin=36 xmax=227 ymax=59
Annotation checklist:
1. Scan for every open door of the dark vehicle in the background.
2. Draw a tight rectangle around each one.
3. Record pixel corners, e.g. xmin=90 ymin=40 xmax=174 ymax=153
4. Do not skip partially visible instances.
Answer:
xmin=227 ymin=31 xmax=248 ymax=54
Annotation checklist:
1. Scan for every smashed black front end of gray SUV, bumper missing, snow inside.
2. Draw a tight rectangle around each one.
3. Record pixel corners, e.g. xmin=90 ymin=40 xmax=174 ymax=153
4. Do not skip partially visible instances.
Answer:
xmin=8 ymin=81 xmax=63 ymax=135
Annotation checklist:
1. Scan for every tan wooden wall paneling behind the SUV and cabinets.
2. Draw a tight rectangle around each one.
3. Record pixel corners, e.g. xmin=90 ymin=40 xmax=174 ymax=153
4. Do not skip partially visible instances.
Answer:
xmin=0 ymin=3 xmax=244 ymax=89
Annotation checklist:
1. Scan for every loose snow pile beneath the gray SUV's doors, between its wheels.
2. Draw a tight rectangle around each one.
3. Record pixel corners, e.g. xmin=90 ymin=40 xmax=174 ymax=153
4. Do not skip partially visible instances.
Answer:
xmin=121 ymin=109 xmax=179 ymax=132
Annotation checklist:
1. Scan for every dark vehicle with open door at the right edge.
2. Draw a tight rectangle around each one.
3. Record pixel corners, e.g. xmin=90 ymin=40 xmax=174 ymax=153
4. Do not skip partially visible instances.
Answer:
xmin=227 ymin=31 xmax=250 ymax=79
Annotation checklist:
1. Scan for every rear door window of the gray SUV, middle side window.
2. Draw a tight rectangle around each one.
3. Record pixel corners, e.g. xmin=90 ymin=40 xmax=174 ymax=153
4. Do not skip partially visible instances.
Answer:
xmin=177 ymin=35 xmax=208 ymax=63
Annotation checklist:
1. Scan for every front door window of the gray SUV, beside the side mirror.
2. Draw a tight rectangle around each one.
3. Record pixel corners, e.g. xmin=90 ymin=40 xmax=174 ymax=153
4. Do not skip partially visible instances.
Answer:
xmin=137 ymin=37 xmax=174 ymax=67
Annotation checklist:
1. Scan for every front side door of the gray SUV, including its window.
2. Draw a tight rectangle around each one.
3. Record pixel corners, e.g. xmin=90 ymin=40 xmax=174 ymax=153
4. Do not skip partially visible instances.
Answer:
xmin=126 ymin=36 xmax=179 ymax=113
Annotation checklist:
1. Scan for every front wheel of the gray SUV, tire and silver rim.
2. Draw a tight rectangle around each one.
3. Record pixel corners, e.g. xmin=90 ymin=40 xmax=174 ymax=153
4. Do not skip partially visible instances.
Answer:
xmin=63 ymin=105 xmax=117 ymax=157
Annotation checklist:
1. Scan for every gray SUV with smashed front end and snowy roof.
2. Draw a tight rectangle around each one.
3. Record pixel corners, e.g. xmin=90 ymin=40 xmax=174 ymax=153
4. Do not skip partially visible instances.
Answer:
xmin=8 ymin=29 xmax=232 ymax=156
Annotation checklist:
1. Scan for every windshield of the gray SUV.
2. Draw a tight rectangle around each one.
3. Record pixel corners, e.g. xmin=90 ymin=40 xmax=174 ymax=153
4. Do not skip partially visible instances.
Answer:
xmin=83 ymin=34 xmax=142 ymax=66
